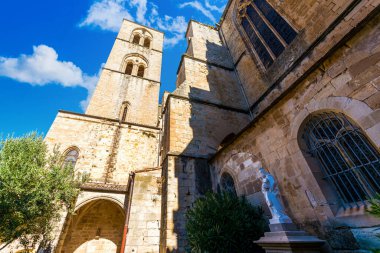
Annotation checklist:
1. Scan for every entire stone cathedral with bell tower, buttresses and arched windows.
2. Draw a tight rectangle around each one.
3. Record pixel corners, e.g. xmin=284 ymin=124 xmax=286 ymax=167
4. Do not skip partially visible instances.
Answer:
xmin=5 ymin=0 xmax=380 ymax=253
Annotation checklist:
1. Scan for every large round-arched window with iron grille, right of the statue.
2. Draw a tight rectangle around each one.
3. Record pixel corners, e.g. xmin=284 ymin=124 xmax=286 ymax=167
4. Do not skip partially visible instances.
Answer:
xmin=302 ymin=112 xmax=380 ymax=207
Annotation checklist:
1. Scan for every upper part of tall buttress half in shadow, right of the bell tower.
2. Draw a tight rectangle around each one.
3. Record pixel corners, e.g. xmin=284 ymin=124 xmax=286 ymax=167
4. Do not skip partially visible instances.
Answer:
xmin=173 ymin=21 xmax=248 ymax=110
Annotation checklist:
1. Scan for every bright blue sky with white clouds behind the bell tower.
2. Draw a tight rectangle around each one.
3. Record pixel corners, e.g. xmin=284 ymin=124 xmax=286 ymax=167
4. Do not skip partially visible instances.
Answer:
xmin=0 ymin=0 xmax=227 ymax=137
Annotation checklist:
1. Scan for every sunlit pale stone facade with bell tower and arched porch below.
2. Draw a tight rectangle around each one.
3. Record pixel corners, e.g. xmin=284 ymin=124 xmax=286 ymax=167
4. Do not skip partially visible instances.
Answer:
xmin=45 ymin=20 xmax=163 ymax=253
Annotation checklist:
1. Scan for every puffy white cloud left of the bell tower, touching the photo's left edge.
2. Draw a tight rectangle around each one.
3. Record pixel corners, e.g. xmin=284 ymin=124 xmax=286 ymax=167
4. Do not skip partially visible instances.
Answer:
xmin=0 ymin=45 xmax=98 ymax=109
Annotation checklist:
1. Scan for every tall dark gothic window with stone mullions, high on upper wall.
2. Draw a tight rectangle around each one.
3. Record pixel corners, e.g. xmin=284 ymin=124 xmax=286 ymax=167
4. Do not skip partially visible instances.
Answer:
xmin=237 ymin=0 xmax=297 ymax=68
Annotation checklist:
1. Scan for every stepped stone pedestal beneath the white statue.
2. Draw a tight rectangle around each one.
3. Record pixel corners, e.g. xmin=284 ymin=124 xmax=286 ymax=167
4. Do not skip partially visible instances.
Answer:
xmin=255 ymin=223 xmax=325 ymax=253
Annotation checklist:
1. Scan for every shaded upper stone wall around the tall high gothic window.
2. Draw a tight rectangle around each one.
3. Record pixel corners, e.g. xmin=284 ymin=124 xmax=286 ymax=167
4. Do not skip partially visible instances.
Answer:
xmin=221 ymin=0 xmax=378 ymax=108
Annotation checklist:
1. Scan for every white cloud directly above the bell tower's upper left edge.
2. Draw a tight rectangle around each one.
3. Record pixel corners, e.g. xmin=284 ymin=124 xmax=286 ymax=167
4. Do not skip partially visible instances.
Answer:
xmin=79 ymin=0 xmax=134 ymax=32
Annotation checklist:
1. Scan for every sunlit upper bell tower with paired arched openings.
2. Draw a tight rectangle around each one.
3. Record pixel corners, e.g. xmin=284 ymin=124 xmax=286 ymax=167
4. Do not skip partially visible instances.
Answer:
xmin=86 ymin=20 xmax=164 ymax=126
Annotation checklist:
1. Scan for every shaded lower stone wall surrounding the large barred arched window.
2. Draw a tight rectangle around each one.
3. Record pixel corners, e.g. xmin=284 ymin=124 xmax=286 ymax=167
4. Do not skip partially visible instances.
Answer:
xmin=212 ymin=12 xmax=380 ymax=249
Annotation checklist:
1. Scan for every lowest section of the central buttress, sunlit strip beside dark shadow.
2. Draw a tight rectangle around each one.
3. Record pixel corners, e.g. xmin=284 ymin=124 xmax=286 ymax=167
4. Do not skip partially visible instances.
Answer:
xmin=160 ymin=155 xmax=211 ymax=253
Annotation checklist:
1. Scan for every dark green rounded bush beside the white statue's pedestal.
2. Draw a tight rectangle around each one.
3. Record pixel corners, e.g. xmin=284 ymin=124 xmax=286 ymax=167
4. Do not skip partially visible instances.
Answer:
xmin=186 ymin=192 xmax=268 ymax=253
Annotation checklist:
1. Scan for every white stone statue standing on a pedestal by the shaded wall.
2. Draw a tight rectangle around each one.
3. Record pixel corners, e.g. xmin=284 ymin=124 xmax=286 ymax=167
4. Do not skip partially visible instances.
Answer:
xmin=255 ymin=162 xmax=292 ymax=224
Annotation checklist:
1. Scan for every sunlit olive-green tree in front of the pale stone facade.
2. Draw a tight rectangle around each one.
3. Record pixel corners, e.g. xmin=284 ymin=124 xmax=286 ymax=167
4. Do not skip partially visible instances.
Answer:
xmin=0 ymin=133 xmax=80 ymax=251
